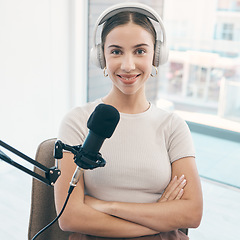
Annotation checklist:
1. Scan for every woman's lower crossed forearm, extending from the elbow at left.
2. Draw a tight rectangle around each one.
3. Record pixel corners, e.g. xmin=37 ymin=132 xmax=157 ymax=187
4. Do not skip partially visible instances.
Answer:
xmin=60 ymin=204 xmax=158 ymax=238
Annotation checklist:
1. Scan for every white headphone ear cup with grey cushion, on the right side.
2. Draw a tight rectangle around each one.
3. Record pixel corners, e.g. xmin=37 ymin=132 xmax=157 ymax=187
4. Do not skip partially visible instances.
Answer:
xmin=153 ymin=40 xmax=168 ymax=67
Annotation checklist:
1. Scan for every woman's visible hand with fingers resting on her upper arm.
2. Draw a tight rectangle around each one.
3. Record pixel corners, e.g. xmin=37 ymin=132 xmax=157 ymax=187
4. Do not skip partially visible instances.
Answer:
xmin=158 ymin=175 xmax=187 ymax=202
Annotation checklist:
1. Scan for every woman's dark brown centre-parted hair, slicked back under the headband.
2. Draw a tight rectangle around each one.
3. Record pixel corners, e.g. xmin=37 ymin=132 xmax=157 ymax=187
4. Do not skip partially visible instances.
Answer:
xmin=101 ymin=11 xmax=157 ymax=48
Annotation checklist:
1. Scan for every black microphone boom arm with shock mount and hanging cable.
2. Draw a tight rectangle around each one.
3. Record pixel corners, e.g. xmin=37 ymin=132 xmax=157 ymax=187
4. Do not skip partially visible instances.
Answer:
xmin=0 ymin=140 xmax=106 ymax=240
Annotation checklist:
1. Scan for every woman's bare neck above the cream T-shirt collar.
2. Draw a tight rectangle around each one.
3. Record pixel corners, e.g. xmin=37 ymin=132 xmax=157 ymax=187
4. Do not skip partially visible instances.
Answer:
xmin=102 ymin=91 xmax=149 ymax=114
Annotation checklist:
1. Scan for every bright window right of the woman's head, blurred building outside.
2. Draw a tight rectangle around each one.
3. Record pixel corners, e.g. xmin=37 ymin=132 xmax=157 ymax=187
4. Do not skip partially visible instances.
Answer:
xmin=159 ymin=0 xmax=240 ymax=124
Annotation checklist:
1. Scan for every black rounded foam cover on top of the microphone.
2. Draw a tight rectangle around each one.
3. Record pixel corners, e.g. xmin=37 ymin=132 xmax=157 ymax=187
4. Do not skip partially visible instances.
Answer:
xmin=87 ymin=103 xmax=120 ymax=138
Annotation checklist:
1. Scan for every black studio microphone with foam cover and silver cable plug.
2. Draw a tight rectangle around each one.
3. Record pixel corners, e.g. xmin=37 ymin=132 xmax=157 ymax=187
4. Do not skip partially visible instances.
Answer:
xmin=70 ymin=103 xmax=120 ymax=187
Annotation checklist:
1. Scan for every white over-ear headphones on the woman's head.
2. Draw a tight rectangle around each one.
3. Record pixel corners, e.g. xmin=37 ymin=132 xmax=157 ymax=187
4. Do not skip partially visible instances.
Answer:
xmin=90 ymin=2 xmax=168 ymax=69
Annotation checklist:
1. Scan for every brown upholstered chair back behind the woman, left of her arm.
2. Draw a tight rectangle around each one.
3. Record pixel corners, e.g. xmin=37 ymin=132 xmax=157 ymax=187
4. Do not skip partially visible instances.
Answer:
xmin=28 ymin=138 xmax=71 ymax=240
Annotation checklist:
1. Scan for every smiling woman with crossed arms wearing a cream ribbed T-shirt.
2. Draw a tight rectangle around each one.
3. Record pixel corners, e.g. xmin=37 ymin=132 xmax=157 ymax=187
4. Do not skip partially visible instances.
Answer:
xmin=55 ymin=2 xmax=202 ymax=239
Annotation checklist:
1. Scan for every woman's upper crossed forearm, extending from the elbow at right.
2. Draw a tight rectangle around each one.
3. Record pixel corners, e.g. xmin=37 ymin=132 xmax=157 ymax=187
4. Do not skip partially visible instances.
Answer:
xmin=105 ymin=200 xmax=201 ymax=232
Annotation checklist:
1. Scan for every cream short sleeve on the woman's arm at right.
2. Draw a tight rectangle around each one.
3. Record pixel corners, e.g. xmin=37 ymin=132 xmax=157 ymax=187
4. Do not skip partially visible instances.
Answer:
xmin=168 ymin=114 xmax=195 ymax=163
